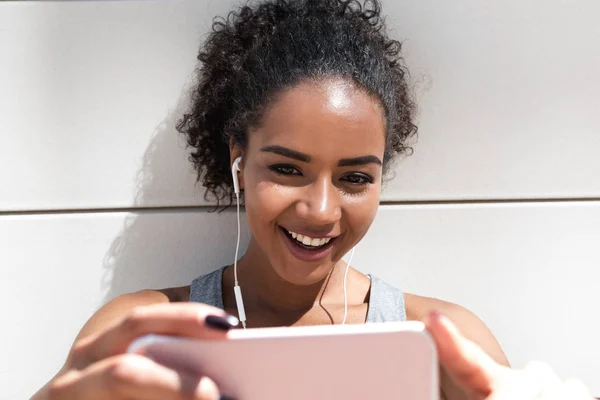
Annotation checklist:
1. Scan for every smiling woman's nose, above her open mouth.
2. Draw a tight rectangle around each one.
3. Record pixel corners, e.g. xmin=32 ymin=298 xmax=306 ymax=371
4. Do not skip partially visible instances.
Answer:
xmin=297 ymin=176 xmax=342 ymax=225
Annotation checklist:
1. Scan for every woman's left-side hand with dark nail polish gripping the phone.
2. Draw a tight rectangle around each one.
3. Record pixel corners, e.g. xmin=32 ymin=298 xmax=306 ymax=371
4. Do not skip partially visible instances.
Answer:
xmin=48 ymin=303 xmax=235 ymax=400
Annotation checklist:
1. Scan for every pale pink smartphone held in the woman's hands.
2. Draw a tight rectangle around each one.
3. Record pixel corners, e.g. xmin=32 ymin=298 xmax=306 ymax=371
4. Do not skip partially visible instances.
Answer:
xmin=129 ymin=321 xmax=439 ymax=400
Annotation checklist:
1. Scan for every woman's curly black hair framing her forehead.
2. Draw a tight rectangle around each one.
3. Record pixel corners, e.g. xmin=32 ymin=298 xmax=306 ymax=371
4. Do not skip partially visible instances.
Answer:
xmin=177 ymin=0 xmax=417 ymax=206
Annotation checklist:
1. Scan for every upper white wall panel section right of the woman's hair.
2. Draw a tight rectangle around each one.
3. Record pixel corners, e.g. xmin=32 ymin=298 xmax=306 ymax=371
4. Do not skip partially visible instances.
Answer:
xmin=384 ymin=0 xmax=600 ymax=199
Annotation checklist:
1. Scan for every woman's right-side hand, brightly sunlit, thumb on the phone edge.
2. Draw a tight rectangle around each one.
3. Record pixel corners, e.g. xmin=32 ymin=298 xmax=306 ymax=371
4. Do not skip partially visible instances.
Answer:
xmin=427 ymin=313 xmax=592 ymax=400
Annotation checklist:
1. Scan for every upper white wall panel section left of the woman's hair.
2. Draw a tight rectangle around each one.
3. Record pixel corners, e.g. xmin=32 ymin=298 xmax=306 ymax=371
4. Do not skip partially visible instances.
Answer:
xmin=0 ymin=1 xmax=231 ymax=210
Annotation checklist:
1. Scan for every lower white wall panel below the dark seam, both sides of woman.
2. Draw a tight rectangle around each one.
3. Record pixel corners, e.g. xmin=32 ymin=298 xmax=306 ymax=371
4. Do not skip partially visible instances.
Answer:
xmin=0 ymin=203 xmax=600 ymax=400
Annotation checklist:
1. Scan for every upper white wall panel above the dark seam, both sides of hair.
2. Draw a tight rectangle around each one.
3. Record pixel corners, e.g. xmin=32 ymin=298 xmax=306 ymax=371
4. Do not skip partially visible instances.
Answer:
xmin=0 ymin=0 xmax=600 ymax=210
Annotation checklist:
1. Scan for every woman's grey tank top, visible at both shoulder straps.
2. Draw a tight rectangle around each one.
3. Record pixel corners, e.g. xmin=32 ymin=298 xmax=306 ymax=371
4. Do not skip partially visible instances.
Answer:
xmin=190 ymin=267 xmax=406 ymax=323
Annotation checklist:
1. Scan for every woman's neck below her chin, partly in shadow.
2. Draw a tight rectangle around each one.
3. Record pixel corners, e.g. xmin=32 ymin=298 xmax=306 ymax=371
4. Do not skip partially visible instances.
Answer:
xmin=238 ymin=239 xmax=346 ymax=319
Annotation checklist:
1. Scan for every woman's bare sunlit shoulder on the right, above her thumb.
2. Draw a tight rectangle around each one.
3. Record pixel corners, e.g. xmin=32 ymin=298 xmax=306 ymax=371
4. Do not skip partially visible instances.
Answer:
xmin=404 ymin=293 xmax=508 ymax=365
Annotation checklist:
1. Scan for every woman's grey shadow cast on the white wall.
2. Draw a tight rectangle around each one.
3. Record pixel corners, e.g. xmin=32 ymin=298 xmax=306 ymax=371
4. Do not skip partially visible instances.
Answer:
xmin=101 ymin=84 xmax=249 ymax=302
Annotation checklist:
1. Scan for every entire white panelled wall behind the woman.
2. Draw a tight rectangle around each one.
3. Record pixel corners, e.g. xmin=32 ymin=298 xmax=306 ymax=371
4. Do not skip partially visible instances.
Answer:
xmin=0 ymin=0 xmax=600 ymax=400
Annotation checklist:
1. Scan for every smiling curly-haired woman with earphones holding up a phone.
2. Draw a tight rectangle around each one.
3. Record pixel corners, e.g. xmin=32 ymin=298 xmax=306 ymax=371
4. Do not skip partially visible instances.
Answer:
xmin=34 ymin=0 xmax=590 ymax=400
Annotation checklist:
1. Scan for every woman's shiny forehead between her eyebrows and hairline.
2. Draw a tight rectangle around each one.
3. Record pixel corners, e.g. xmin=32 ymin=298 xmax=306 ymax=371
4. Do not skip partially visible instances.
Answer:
xmin=249 ymin=79 xmax=385 ymax=160
